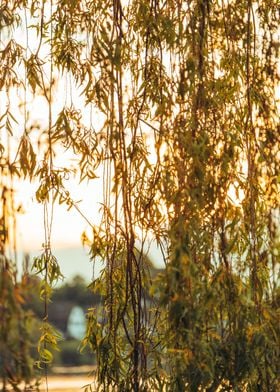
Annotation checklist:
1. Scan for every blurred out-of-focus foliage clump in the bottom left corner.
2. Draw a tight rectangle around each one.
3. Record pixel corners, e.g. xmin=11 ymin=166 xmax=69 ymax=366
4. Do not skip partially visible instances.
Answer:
xmin=0 ymin=255 xmax=39 ymax=391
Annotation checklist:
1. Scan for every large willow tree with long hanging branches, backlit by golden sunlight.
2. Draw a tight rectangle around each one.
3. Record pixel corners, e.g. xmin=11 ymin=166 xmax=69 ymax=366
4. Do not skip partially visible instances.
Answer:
xmin=0 ymin=0 xmax=279 ymax=391
